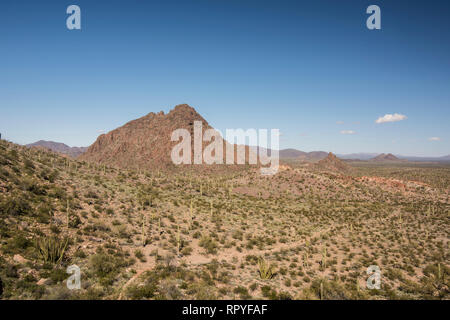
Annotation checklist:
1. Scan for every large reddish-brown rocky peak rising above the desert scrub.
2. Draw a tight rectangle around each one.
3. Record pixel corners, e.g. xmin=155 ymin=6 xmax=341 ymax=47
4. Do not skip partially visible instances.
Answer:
xmin=80 ymin=104 xmax=255 ymax=169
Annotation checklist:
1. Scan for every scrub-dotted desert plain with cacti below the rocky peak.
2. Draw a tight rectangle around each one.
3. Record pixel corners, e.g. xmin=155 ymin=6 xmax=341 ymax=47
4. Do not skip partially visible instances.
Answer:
xmin=0 ymin=140 xmax=450 ymax=299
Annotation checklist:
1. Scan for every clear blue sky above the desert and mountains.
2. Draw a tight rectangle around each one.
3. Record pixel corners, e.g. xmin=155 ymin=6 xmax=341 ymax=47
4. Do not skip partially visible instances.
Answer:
xmin=0 ymin=0 xmax=450 ymax=156
